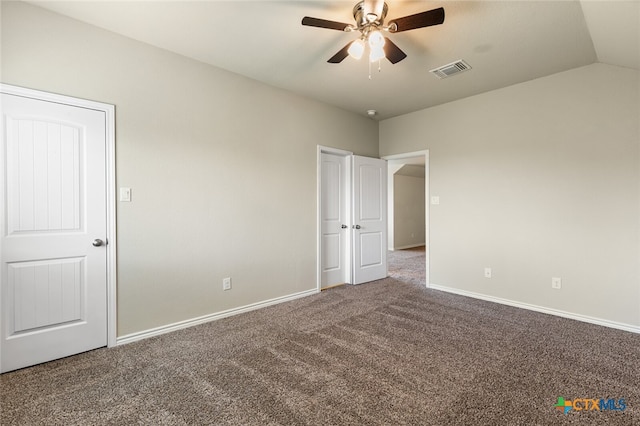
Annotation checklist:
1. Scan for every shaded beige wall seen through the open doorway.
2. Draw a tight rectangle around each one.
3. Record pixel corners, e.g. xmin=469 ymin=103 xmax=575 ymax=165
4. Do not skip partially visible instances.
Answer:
xmin=393 ymin=173 xmax=425 ymax=250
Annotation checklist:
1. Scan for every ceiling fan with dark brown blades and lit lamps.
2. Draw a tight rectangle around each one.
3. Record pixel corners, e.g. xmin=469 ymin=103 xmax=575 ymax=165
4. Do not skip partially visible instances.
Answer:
xmin=302 ymin=0 xmax=444 ymax=64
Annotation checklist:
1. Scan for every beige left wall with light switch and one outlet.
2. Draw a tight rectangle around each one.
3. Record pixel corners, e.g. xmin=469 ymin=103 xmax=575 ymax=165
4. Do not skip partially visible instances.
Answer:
xmin=1 ymin=2 xmax=378 ymax=336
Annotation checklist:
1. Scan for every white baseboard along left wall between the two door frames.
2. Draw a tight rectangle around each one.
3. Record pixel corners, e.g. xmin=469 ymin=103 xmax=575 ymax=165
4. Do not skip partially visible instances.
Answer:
xmin=116 ymin=289 xmax=319 ymax=346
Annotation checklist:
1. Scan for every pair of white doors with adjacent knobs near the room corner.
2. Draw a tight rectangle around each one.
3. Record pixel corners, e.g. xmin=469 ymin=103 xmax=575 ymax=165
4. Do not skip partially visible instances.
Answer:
xmin=320 ymin=152 xmax=387 ymax=288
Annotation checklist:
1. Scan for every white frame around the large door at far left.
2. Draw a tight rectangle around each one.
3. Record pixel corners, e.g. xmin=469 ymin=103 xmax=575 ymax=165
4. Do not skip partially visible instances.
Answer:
xmin=0 ymin=83 xmax=117 ymax=347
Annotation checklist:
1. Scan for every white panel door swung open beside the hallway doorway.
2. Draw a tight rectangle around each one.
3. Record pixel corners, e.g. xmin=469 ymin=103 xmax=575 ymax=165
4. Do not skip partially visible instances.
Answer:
xmin=352 ymin=155 xmax=387 ymax=284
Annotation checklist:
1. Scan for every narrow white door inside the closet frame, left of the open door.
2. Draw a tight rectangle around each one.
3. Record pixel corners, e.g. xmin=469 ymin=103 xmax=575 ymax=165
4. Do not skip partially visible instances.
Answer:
xmin=320 ymin=153 xmax=350 ymax=288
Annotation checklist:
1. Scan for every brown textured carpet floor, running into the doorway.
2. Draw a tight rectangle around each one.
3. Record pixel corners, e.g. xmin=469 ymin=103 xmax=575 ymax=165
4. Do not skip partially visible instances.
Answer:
xmin=0 ymin=249 xmax=640 ymax=425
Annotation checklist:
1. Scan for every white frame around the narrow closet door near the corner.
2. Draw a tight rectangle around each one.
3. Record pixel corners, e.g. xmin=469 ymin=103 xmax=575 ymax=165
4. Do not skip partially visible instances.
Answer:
xmin=316 ymin=145 xmax=353 ymax=292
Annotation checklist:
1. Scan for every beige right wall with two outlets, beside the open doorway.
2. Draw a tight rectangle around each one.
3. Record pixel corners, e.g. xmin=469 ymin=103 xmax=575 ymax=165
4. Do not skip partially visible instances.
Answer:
xmin=380 ymin=64 xmax=640 ymax=326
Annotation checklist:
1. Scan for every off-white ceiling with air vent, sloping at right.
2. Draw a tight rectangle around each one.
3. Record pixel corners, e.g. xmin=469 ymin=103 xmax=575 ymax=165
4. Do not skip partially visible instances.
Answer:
xmin=30 ymin=0 xmax=640 ymax=119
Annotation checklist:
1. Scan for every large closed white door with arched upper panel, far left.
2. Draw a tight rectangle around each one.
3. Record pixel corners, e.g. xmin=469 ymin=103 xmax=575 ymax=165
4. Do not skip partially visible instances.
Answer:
xmin=0 ymin=93 xmax=107 ymax=372
